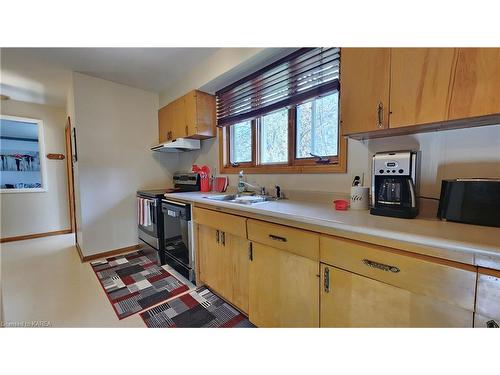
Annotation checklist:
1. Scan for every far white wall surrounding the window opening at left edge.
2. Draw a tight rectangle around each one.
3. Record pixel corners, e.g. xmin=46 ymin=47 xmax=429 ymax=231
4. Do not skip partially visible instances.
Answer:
xmin=0 ymin=100 xmax=70 ymax=238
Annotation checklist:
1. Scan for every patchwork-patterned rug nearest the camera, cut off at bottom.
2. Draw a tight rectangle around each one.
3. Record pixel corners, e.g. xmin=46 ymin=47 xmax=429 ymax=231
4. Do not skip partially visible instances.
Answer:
xmin=140 ymin=286 xmax=255 ymax=328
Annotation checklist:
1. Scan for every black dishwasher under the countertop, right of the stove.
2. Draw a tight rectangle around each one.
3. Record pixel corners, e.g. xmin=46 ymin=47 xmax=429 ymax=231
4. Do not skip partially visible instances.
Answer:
xmin=161 ymin=199 xmax=195 ymax=282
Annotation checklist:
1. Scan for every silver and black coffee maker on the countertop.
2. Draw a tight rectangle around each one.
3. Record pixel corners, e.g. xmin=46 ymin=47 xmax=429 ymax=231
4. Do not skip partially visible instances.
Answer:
xmin=370 ymin=151 xmax=420 ymax=219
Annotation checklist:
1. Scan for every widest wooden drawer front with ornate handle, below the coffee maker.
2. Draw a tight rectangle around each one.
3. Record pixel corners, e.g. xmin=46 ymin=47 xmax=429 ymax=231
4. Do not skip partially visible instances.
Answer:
xmin=320 ymin=236 xmax=477 ymax=311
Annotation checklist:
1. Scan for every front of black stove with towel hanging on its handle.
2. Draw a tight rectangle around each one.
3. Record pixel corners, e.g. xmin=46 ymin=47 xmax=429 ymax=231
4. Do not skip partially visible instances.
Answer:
xmin=137 ymin=189 xmax=167 ymax=265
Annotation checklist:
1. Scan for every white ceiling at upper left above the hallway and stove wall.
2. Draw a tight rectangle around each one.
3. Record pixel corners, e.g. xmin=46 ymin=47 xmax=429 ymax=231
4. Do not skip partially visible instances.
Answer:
xmin=0 ymin=48 xmax=218 ymax=106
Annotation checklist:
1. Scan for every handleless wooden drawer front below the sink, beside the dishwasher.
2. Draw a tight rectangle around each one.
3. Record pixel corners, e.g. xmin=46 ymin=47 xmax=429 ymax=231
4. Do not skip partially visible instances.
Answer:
xmin=193 ymin=207 xmax=247 ymax=238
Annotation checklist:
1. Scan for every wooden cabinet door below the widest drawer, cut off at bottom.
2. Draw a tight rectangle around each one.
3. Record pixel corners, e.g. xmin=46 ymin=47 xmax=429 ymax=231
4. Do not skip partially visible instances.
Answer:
xmin=320 ymin=264 xmax=473 ymax=327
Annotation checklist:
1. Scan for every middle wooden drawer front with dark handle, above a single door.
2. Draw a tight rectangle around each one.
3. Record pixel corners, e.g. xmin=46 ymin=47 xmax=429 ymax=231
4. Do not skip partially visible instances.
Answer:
xmin=247 ymin=220 xmax=319 ymax=260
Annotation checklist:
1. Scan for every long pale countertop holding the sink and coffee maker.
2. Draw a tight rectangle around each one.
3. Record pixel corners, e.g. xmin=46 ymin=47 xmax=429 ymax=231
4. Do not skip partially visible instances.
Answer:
xmin=165 ymin=192 xmax=500 ymax=268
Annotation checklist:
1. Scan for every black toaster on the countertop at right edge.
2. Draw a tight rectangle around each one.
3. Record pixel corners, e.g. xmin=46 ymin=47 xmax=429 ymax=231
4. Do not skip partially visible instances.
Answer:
xmin=437 ymin=178 xmax=500 ymax=227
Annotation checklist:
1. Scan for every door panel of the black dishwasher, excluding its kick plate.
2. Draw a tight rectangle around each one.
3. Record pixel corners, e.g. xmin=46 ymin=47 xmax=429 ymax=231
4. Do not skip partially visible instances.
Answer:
xmin=161 ymin=200 xmax=193 ymax=268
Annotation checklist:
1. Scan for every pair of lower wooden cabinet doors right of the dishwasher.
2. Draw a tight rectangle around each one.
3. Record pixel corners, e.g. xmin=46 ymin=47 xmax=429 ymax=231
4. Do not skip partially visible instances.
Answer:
xmin=198 ymin=225 xmax=249 ymax=313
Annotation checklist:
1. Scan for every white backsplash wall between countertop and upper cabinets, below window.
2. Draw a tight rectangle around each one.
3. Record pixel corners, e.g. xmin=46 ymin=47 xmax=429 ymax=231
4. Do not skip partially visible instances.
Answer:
xmin=180 ymin=125 xmax=500 ymax=198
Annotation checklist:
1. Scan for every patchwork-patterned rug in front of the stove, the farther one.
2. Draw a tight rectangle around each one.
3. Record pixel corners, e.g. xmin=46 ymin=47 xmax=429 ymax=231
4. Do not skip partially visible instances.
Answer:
xmin=90 ymin=250 xmax=189 ymax=319
